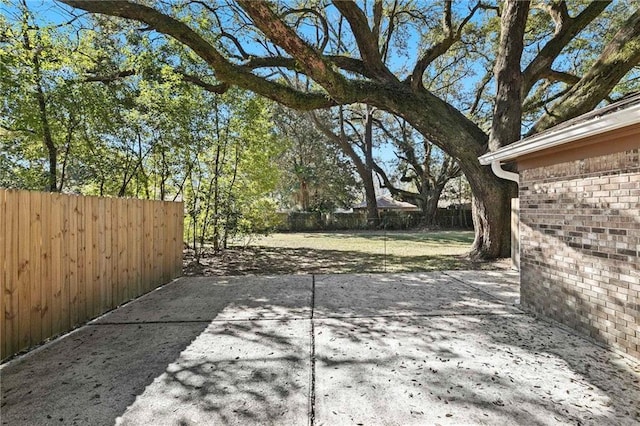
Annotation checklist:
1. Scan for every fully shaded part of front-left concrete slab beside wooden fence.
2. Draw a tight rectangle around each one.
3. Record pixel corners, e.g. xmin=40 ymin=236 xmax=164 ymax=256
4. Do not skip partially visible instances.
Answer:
xmin=0 ymin=323 xmax=207 ymax=425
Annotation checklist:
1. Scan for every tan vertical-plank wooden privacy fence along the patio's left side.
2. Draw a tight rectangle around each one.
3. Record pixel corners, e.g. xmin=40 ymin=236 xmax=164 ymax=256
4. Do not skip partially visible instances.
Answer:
xmin=0 ymin=189 xmax=183 ymax=359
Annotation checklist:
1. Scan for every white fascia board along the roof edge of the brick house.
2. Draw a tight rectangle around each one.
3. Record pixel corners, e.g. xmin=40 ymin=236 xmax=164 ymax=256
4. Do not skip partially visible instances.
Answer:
xmin=478 ymin=104 xmax=640 ymax=166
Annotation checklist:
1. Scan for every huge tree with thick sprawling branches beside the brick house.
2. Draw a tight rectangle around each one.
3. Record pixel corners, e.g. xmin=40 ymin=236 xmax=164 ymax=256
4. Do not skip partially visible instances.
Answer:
xmin=56 ymin=0 xmax=640 ymax=257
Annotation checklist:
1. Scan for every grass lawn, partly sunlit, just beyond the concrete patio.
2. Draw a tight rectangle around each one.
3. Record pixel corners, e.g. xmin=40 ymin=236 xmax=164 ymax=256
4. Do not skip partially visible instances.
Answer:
xmin=185 ymin=231 xmax=506 ymax=275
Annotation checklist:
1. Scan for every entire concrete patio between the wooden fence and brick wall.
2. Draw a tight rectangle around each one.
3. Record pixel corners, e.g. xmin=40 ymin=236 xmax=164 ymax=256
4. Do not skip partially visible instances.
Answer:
xmin=0 ymin=271 xmax=640 ymax=425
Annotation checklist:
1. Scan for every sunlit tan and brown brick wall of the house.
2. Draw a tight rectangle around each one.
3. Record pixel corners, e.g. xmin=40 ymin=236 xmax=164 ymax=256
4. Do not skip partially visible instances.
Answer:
xmin=520 ymin=150 xmax=640 ymax=358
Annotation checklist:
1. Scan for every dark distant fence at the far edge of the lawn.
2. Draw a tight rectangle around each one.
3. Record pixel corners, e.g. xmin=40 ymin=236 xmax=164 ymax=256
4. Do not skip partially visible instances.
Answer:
xmin=277 ymin=209 xmax=473 ymax=232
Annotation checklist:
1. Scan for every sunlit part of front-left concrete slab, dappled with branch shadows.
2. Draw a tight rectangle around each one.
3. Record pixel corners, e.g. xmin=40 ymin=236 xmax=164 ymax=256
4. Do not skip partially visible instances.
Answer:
xmin=116 ymin=321 xmax=310 ymax=425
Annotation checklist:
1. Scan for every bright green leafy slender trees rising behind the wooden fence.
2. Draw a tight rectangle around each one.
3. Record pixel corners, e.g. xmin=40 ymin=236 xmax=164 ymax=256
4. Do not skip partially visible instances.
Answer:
xmin=0 ymin=3 xmax=283 ymax=255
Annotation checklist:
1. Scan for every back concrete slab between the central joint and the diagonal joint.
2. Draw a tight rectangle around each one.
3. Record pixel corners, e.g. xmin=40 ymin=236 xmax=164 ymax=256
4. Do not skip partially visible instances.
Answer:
xmin=315 ymin=272 xmax=520 ymax=318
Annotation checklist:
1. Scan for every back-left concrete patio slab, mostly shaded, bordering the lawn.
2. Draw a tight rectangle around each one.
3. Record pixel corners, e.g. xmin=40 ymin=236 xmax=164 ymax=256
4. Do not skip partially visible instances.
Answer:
xmin=94 ymin=275 xmax=312 ymax=324
